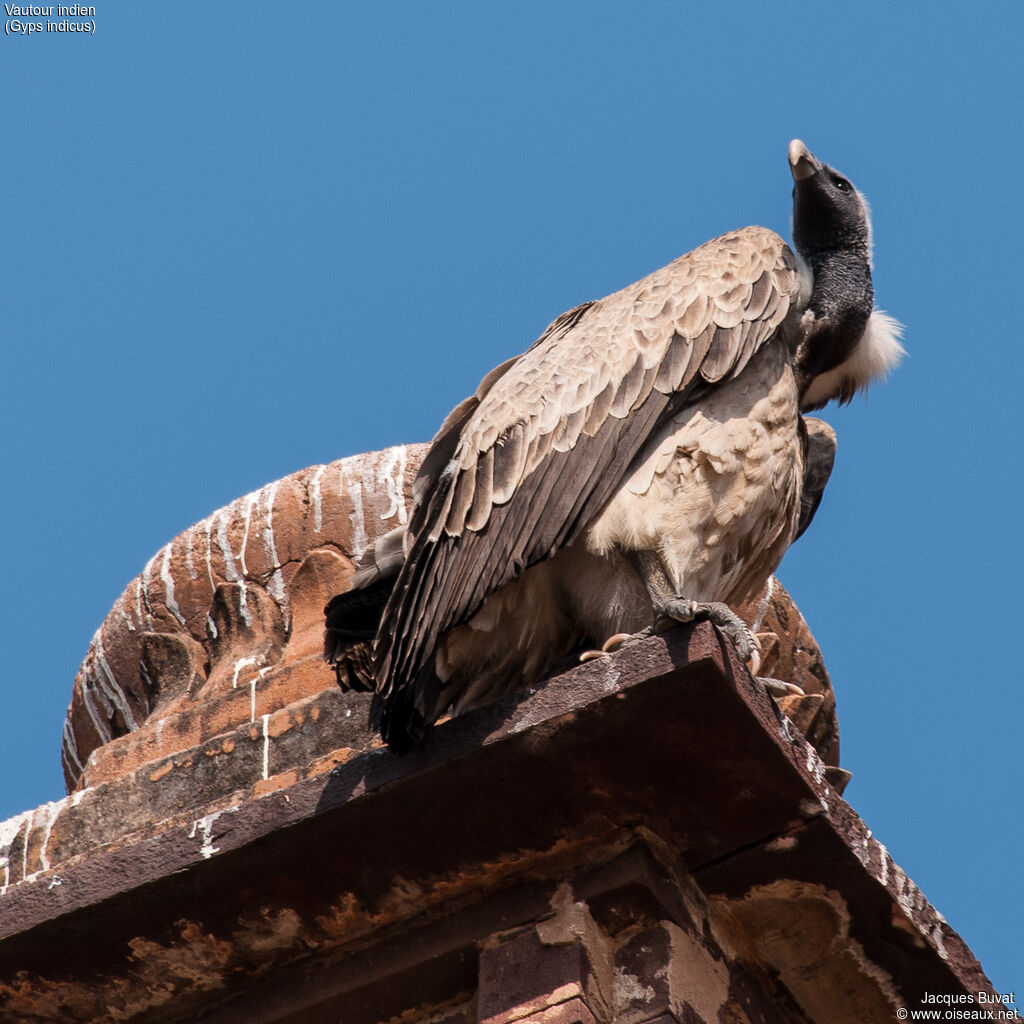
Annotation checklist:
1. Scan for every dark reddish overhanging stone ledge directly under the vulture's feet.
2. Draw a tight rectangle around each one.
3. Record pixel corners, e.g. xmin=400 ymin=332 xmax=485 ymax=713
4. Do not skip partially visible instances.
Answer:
xmin=0 ymin=624 xmax=990 ymax=1022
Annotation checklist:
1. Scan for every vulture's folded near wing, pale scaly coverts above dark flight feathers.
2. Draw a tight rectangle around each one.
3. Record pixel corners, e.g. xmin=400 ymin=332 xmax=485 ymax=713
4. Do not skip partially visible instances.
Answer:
xmin=376 ymin=227 xmax=800 ymax=733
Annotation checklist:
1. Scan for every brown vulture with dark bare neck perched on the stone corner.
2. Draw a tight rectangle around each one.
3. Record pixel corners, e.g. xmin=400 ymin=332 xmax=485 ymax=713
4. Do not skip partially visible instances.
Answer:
xmin=325 ymin=139 xmax=903 ymax=753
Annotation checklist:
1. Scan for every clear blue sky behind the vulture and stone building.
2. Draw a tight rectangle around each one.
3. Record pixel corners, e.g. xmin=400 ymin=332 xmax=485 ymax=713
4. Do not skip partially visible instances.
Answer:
xmin=0 ymin=0 xmax=1024 ymax=993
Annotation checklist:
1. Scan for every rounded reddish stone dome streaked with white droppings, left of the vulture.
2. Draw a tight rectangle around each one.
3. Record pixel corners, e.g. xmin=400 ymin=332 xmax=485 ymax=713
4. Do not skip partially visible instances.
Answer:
xmin=62 ymin=444 xmax=427 ymax=788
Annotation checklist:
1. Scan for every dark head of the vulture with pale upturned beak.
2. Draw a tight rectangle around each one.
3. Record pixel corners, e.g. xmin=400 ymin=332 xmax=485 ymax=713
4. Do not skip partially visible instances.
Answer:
xmin=790 ymin=138 xmax=871 ymax=266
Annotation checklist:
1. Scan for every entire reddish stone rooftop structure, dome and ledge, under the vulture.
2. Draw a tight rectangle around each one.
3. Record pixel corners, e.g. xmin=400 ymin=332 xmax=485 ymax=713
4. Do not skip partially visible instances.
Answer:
xmin=0 ymin=445 xmax=990 ymax=1024
